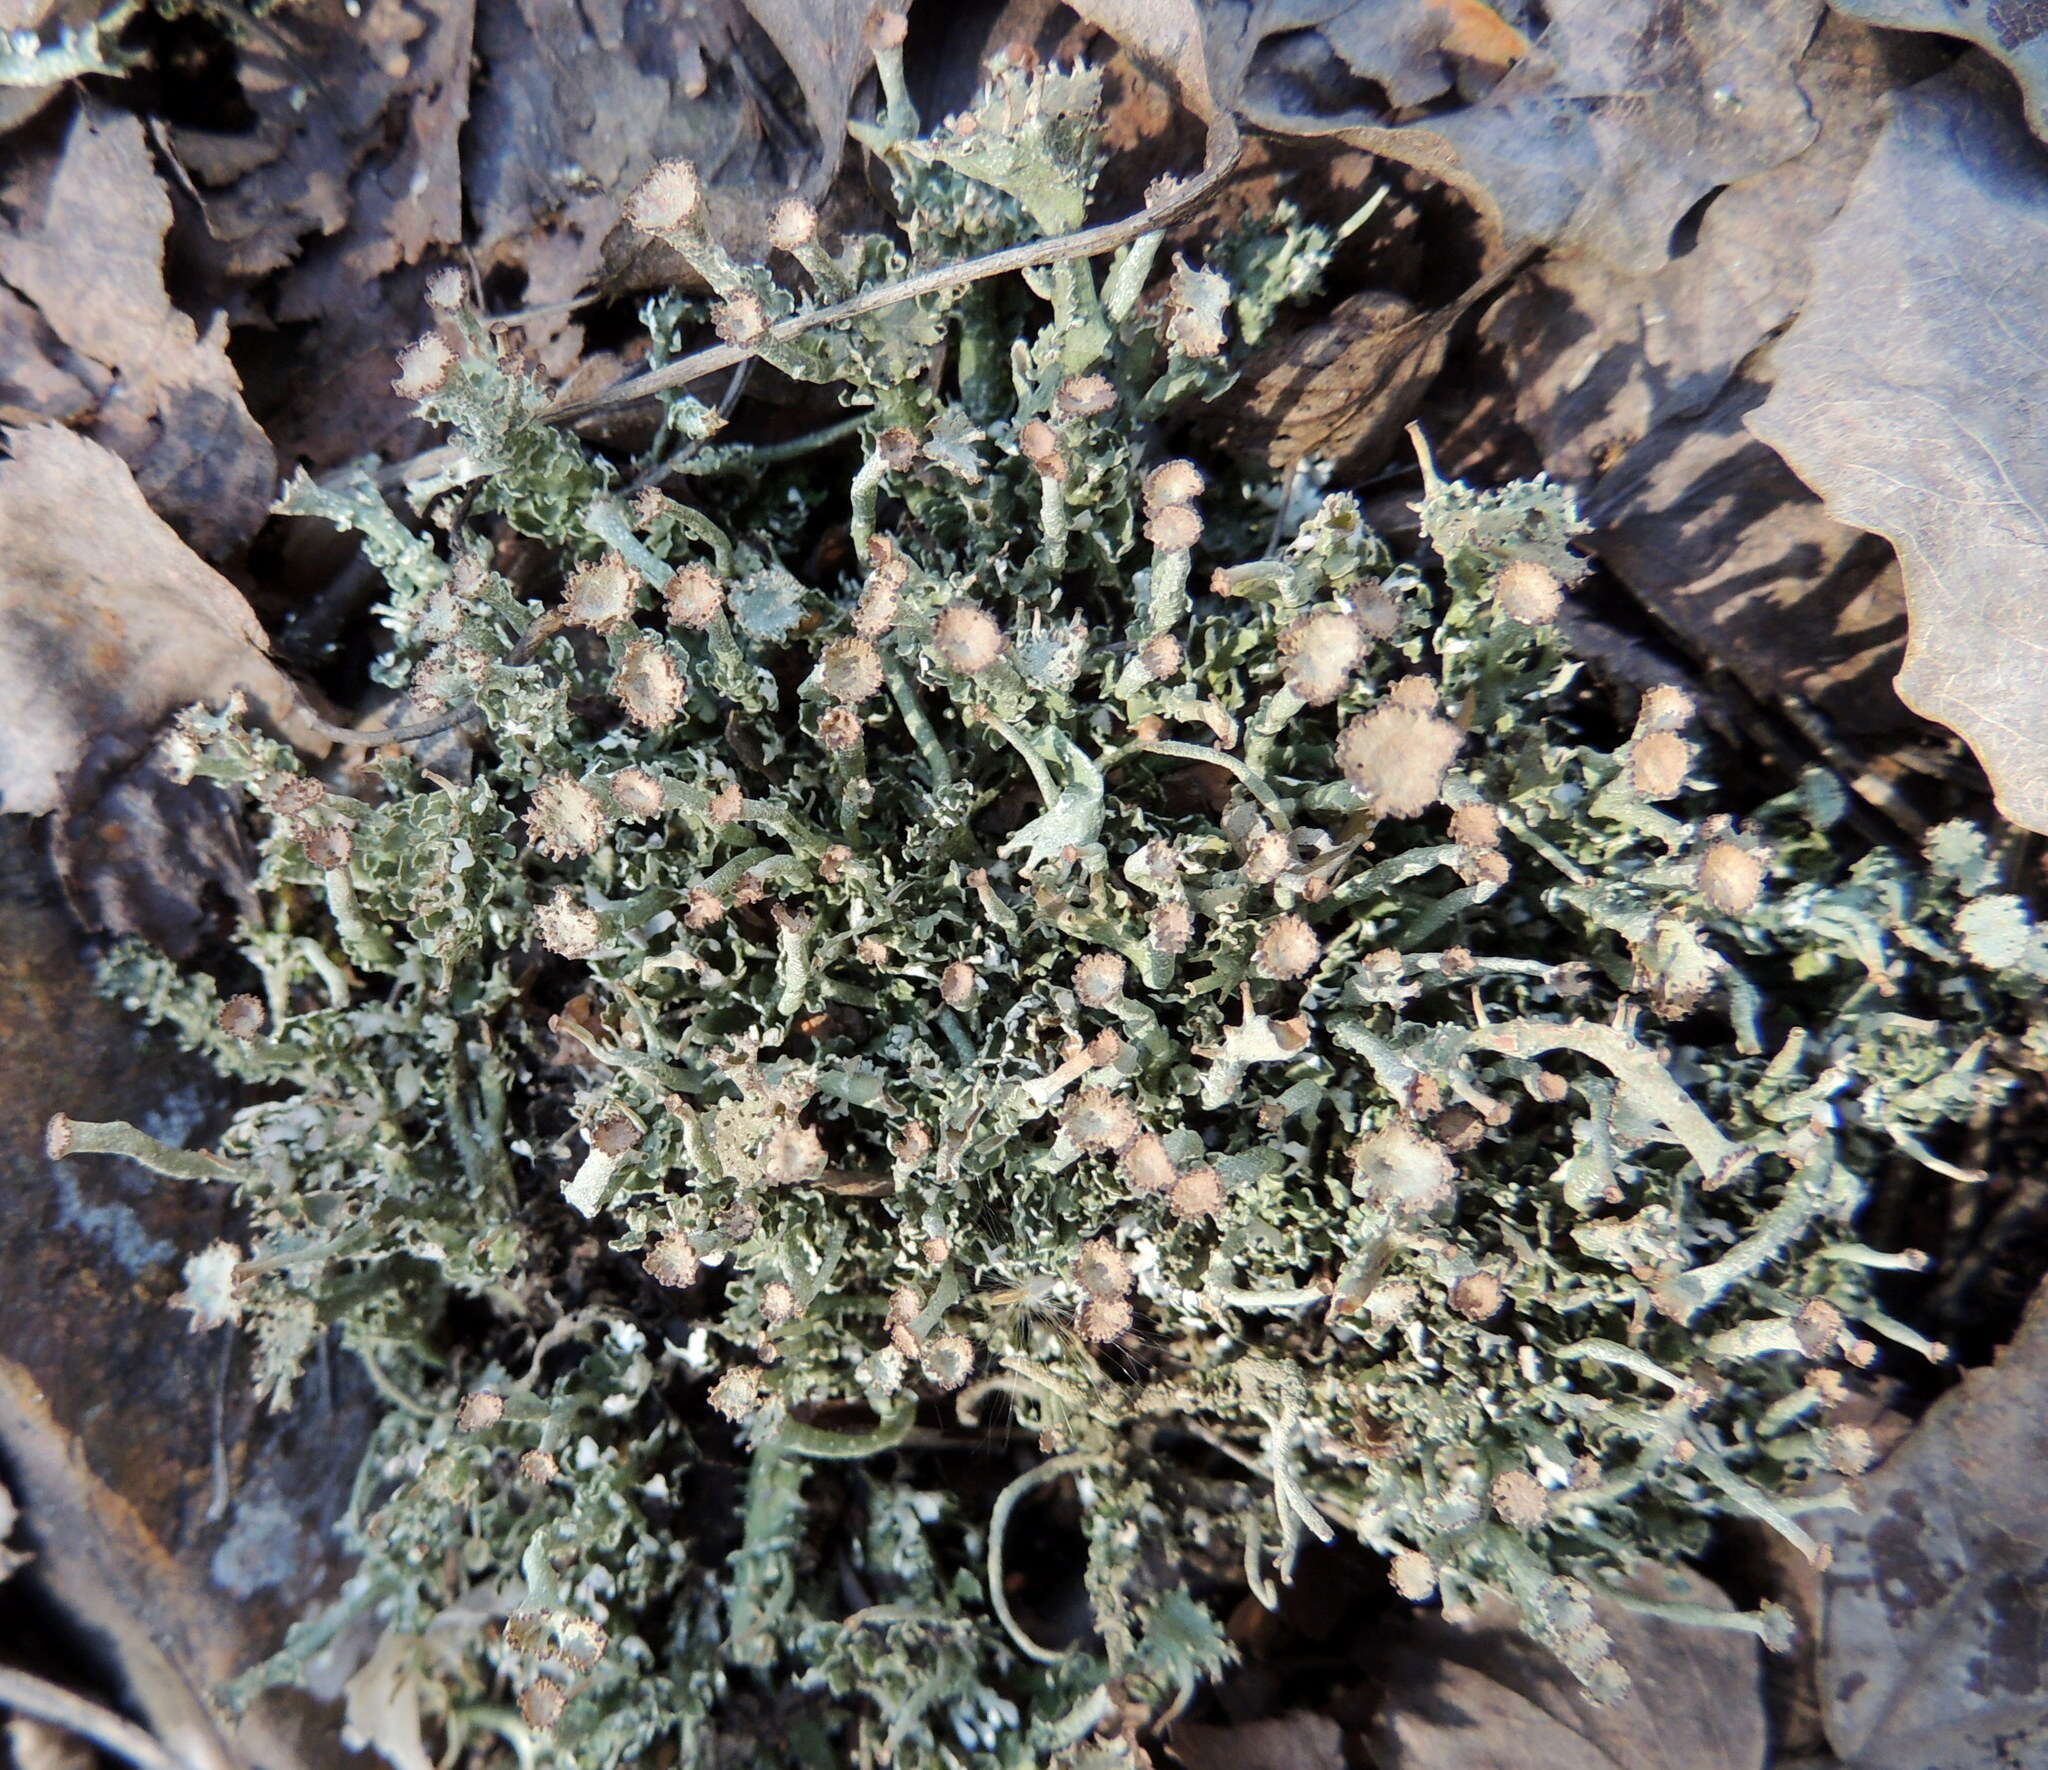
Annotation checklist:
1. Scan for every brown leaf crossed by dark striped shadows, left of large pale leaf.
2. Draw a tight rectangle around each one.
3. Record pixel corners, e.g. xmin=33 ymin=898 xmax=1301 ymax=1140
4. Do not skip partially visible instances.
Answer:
xmin=1466 ymin=16 xmax=1939 ymax=733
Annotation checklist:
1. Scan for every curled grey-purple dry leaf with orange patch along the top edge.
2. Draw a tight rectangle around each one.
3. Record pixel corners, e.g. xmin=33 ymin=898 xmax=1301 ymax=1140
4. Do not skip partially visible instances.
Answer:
xmin=1077 ymin=0 xmax=1821 ymax=270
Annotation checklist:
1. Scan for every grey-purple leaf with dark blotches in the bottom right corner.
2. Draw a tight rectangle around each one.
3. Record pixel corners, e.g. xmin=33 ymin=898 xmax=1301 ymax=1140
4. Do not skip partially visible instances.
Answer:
xmin=1815 ymin=1291 xmax=2048 ymax=1770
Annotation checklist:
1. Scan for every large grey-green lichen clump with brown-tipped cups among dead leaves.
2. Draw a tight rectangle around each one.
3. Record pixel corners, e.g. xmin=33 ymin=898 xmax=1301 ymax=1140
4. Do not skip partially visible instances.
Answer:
xmin=53 ymin=45 xmax=2048 ymax=1770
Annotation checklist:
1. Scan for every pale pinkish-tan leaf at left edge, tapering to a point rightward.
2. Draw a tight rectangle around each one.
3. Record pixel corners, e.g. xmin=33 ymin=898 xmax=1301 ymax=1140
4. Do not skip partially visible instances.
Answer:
xmin=0 ymin=426 xmax=326 ymax=813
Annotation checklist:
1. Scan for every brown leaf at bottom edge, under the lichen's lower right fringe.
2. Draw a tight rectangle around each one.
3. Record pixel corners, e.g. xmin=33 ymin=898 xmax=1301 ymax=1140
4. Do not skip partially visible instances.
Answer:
xmin=1372 ymin=1573 xmax=1765 ymax=1770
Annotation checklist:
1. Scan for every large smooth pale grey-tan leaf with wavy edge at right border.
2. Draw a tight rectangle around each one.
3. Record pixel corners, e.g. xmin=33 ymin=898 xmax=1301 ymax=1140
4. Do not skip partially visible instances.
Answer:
xmin=1749 ymin=74 xmax=2048 ymax=830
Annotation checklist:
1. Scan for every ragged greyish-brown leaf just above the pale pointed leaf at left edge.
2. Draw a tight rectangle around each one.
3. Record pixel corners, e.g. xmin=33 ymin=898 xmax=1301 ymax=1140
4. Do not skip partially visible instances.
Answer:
xmin=0 ymin=107 xmax=276 ymax=557
